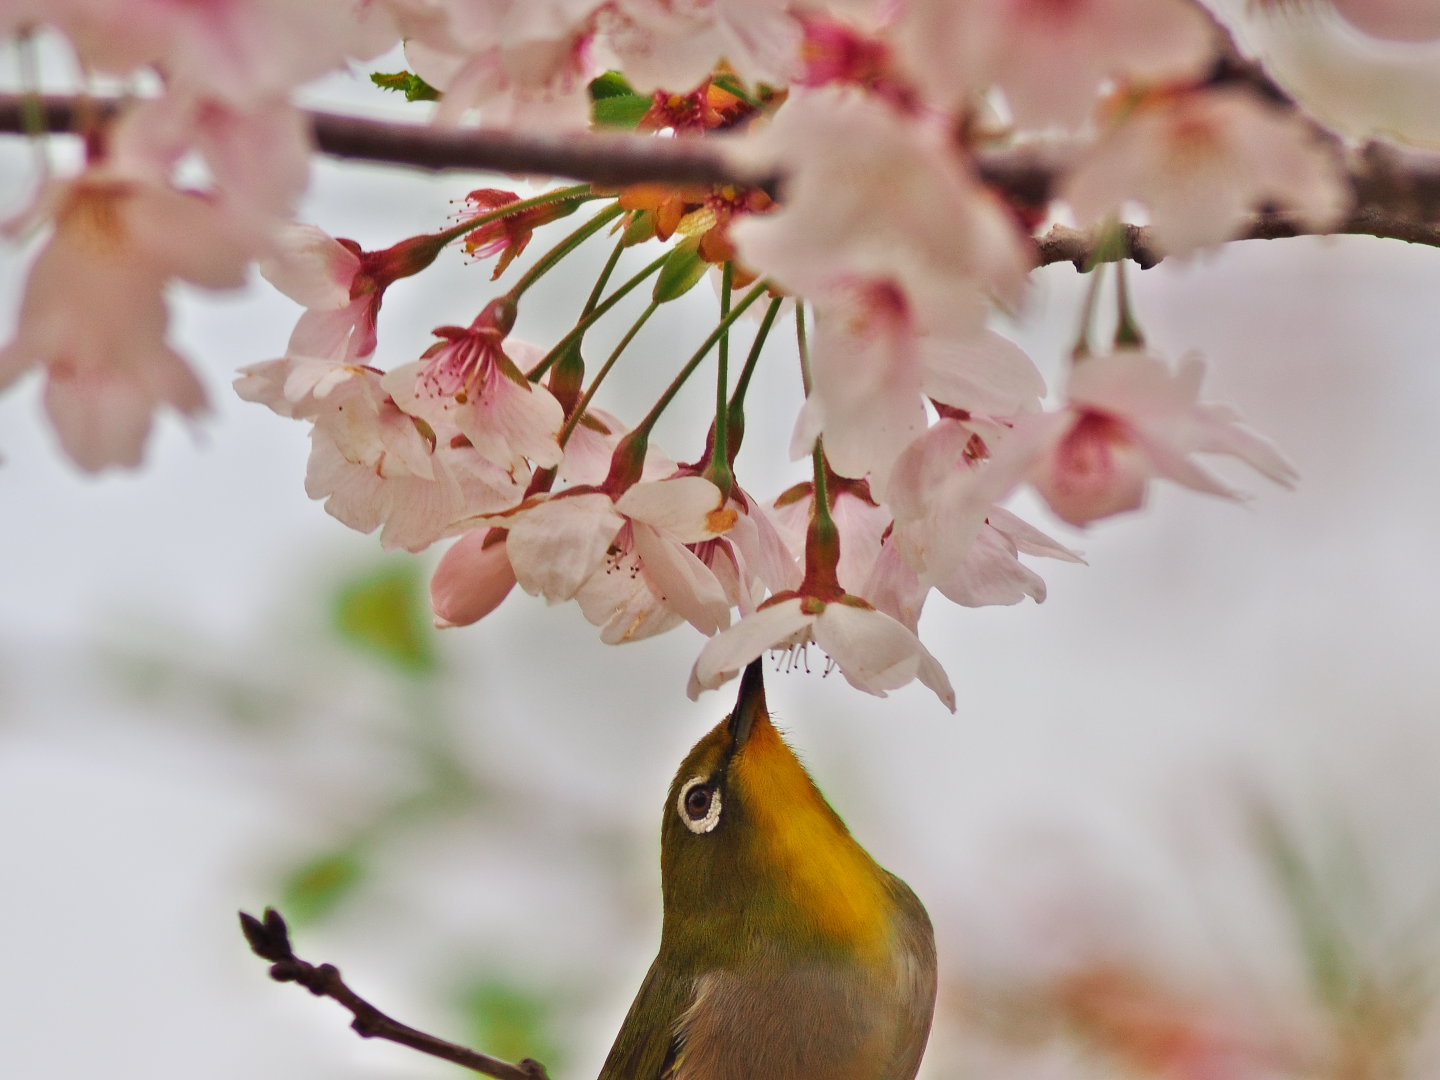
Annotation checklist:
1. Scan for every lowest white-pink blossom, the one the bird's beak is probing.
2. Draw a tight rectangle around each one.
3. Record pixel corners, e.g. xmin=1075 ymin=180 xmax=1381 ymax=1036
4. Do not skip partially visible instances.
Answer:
xmin=687 ymin=593 xmax=955 ymax=713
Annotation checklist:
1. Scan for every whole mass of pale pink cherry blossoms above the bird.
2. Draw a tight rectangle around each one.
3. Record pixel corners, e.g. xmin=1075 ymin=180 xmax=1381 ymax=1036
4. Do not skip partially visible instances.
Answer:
xmin=0 ymin=0 xmax=1393 ymax=708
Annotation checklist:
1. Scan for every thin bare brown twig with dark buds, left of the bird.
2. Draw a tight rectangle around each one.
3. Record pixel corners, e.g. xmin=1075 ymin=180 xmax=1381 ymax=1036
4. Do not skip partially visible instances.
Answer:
xmin=240 ymin=907 xmax=549 ymax=1080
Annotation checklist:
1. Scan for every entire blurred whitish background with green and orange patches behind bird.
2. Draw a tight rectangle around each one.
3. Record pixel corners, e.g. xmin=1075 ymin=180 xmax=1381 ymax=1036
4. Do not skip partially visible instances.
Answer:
xmin=0 ymin=23 xmax=1440 ymax=1080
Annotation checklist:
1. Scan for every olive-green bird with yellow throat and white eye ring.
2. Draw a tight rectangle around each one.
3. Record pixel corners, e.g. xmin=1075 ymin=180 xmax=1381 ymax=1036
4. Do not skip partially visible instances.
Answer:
xmin=599 ymin=660 xmax=936 ymax=1080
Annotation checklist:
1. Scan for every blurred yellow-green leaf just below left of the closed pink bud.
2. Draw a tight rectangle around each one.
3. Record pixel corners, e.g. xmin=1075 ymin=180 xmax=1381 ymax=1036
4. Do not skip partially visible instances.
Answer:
xmin=334 ymin=559 xmax=439 ymax=674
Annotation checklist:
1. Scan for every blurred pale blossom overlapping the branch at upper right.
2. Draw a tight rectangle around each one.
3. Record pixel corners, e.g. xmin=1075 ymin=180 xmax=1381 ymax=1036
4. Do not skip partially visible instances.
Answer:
xmin=1061 ymin=89 xmax=1351 ymax=253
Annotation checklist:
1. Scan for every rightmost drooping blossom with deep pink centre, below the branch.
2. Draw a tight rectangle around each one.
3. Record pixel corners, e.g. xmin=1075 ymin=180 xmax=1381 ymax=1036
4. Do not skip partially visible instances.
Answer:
xmin=1008 ymin=348 xmax=1296 ymax=526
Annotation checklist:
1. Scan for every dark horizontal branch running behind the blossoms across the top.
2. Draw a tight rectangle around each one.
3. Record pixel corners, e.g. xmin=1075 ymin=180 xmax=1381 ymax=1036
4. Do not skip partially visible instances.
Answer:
xmin=0 ymin=95 xmax=1440 ymax=268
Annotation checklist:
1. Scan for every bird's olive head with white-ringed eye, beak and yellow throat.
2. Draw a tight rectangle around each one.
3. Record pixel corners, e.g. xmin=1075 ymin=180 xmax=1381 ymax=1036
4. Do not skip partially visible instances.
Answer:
xmin=661 ymin=661 xmax=894 ymax=965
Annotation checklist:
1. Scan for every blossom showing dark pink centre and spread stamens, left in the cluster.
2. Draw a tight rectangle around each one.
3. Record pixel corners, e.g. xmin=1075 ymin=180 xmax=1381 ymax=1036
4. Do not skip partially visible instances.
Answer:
xmin=384 ymin=325 xmax=564 ymax=469
